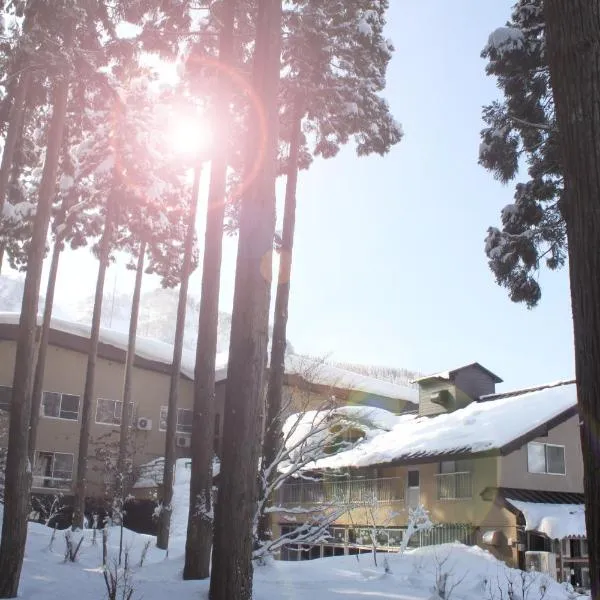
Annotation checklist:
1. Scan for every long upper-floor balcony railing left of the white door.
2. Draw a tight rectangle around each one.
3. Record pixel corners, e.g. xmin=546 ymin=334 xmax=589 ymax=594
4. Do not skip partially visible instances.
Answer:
xmin=277 ymin=477 xmax=404 ymax=506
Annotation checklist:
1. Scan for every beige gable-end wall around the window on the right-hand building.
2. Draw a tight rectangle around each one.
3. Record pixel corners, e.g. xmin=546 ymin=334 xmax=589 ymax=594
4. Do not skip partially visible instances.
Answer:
xmin=499 ymin=415 xmax=583 ymax=493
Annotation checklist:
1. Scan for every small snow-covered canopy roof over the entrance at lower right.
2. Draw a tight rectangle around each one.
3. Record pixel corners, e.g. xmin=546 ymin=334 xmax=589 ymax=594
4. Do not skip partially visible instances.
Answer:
xmin=506 ymin=498 xmax=586 ymax=540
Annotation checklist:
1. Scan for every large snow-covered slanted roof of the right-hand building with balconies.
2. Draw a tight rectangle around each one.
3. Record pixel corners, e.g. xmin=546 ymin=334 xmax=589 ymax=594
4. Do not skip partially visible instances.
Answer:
xmin=309 ymin=384 xmax=577 ymax=469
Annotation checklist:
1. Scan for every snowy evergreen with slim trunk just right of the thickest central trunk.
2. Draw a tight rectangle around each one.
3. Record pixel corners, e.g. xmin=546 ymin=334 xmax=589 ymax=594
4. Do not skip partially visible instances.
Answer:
xmin=258 ymin=0 xmax=402 ymax=541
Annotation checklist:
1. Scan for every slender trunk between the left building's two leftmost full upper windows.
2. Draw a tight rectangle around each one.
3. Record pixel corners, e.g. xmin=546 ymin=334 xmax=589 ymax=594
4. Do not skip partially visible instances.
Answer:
xmin=73 ymin=192 xmax=117 ymax=529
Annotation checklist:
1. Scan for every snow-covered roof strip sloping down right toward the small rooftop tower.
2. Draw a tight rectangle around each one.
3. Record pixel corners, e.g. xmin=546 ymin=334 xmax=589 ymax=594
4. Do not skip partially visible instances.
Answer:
xmin=285 ymin=354 xmax=419 ymax=404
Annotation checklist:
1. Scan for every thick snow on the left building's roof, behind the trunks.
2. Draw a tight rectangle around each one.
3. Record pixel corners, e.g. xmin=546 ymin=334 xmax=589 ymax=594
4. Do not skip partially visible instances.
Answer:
xmin=0 ymin=312 xmax=227 ymax=382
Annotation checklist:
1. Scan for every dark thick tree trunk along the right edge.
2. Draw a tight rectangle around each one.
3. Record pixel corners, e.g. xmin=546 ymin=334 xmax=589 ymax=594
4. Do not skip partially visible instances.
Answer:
xmin=544 ymin=0 xmax=600 ymax=600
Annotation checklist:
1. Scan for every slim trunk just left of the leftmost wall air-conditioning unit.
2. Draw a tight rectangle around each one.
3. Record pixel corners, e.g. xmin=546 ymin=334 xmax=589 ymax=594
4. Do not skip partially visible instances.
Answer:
xmin=116 ymin=240 xmax=146 ymax=512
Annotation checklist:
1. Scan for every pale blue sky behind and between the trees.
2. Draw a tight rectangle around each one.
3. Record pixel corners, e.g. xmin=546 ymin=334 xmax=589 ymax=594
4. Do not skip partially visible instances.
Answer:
xmin=5 ymin=0 xmax=574 ymax=389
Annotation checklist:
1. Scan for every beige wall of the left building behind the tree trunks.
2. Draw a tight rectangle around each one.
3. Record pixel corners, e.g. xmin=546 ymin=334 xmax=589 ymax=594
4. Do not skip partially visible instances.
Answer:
xmin=0 ymin=340 xmax=225 ymax=495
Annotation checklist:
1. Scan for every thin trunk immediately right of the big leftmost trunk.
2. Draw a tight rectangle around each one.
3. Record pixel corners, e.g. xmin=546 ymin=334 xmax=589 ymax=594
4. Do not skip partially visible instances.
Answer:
xmin=29 ymin=239 xmax=63 ymax=464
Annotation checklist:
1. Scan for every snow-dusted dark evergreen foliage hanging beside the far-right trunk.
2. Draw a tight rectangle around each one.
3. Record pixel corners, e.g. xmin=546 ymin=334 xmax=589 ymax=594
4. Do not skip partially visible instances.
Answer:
xmin=479 ymin=0 xmax=567 ymax=307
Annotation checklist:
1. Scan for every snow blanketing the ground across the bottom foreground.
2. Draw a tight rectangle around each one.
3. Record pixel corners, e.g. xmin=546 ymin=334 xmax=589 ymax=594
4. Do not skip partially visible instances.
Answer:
xmin=4 ymin=508 xmax=580 ymax=600
